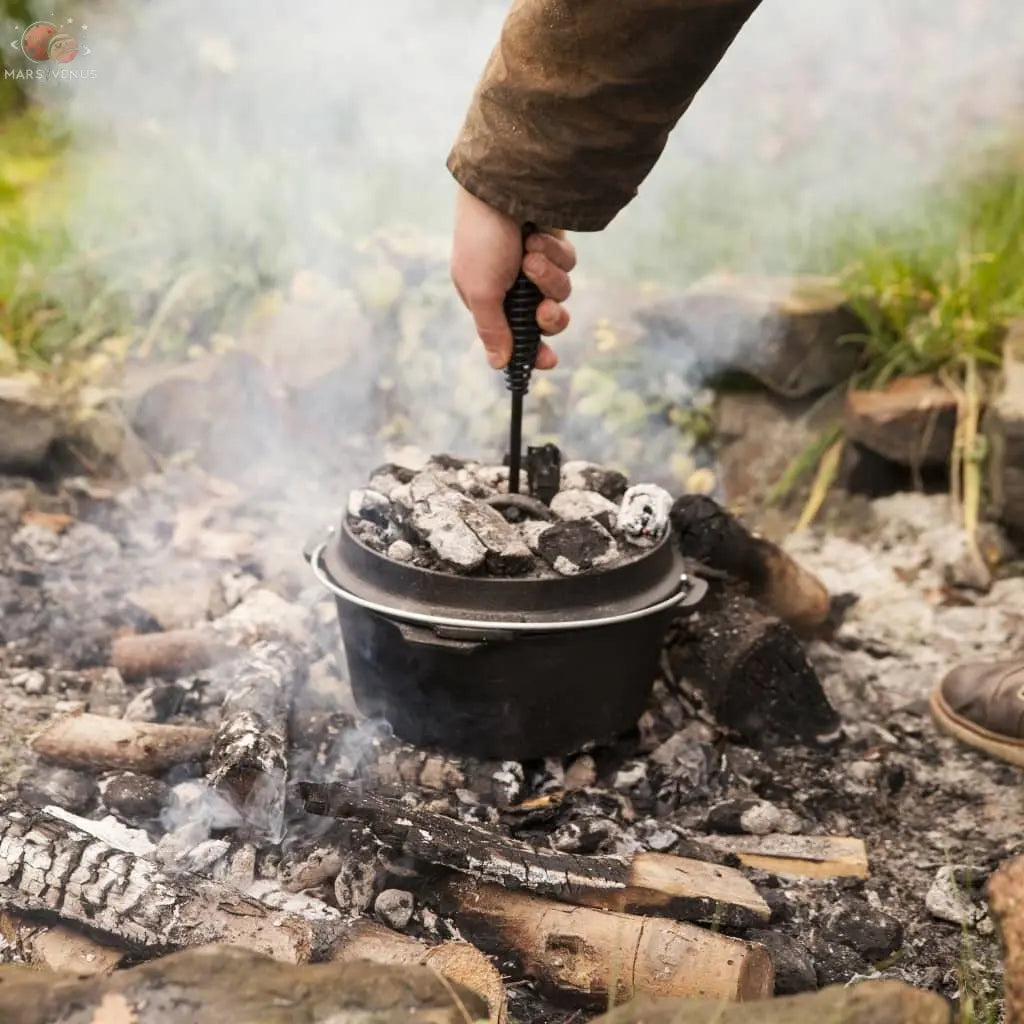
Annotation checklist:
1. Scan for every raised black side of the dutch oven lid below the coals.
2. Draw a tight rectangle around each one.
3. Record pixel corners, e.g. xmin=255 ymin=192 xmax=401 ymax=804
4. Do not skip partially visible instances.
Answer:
xmin=324 ymin=514 xmax=684 ymax=623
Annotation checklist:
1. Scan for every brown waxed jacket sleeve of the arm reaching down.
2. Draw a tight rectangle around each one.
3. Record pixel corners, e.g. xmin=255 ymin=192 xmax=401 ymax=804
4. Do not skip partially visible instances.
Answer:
xmin=447 ymin=0 xmax=760 ymax=231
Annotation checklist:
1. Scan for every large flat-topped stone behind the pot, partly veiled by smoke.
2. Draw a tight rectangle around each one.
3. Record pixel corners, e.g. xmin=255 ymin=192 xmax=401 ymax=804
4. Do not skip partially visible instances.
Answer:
xmin=638 ymin=273 xmax=864 ymax=398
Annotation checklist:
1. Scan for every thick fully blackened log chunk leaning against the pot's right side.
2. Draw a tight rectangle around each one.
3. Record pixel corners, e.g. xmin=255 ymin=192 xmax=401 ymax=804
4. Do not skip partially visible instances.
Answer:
xmin=666 ymin=586 xmax=840 ymax=746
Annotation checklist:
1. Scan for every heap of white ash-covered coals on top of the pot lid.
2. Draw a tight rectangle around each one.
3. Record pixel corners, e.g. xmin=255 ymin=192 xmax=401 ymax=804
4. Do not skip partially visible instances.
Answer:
xmin=347 ymin=455 xmax=672 ymax=578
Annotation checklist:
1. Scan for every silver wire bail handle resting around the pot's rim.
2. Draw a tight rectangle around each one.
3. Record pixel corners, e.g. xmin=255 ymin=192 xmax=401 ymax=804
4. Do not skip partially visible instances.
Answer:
xmin=309 ymin=541 xmax=708 ymax=633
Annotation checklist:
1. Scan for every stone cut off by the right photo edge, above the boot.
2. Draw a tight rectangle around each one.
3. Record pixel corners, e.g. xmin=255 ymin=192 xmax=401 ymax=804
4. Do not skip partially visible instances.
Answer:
xmin=984 ymin=318 xmax=1024 ymax=530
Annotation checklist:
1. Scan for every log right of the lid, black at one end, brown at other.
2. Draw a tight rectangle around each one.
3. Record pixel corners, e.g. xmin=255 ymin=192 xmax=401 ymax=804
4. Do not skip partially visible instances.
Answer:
xmin=672 ymin=495 xmax=833 ymax=630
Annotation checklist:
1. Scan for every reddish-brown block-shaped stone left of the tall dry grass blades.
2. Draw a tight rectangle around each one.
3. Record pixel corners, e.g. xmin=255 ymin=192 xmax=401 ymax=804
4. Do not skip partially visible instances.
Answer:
xmin=843 ymin=375 xmax=956 ymax=467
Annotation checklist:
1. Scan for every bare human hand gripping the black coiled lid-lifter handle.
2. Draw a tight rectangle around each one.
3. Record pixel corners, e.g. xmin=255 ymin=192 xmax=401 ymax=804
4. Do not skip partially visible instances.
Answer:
xmin=452 ymin=185 xmax=575 ymax=370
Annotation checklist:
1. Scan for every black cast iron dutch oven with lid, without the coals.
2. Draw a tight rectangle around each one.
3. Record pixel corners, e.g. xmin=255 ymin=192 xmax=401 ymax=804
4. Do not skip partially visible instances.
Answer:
xmin=305 ymin=515 xmax=708 ymax=760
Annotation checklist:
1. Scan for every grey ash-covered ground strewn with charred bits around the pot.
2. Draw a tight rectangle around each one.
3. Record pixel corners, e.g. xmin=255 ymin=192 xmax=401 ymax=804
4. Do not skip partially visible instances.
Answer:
xmin=0 ymin=466 xmax=1024 ymax=1022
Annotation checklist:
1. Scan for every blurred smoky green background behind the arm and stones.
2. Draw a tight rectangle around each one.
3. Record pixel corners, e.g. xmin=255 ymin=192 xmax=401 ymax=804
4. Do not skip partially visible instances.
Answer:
xmin=0 ymin=0 xmax=1024 ymax=520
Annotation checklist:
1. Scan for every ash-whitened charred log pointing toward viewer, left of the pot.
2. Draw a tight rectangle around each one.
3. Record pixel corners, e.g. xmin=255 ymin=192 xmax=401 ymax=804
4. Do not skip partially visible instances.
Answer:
xmin=209 ymin=640 xmax=305 ymax=842
